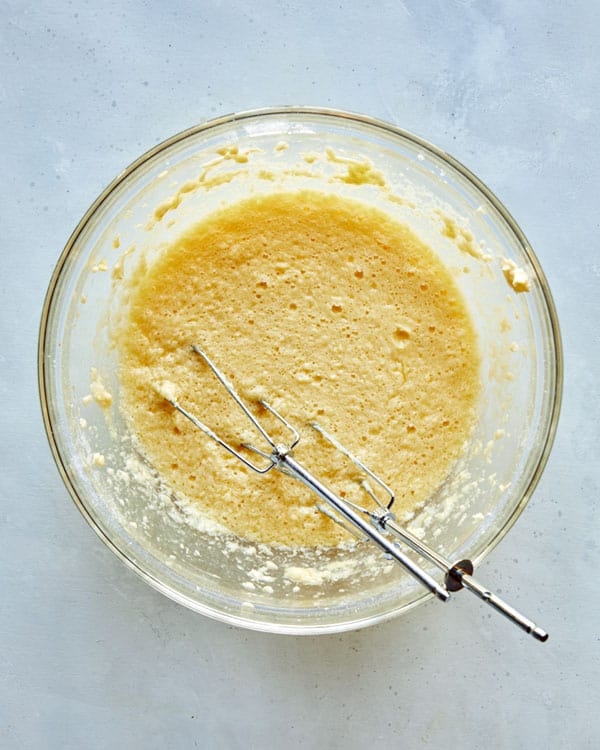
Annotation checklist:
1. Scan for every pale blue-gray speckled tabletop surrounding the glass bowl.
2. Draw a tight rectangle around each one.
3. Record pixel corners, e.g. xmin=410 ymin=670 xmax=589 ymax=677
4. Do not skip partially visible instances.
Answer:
xmin=0 ymin=0 xmax=600 ymax=750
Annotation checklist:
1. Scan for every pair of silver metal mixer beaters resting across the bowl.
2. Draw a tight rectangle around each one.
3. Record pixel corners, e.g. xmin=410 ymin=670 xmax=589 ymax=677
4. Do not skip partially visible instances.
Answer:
xmin=161 ymin=345 xmax=548 ymax=641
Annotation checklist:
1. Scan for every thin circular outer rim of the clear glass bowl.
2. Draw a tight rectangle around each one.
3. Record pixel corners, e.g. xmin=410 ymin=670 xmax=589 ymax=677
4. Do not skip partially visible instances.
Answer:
xmin=37 ymin=105 xmax=564 ymax=635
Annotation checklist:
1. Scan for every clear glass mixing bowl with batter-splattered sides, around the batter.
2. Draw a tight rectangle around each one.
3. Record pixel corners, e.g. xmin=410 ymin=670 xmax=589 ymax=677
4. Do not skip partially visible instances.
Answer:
xmin=38 ymin=107 xmax=562 ymax=634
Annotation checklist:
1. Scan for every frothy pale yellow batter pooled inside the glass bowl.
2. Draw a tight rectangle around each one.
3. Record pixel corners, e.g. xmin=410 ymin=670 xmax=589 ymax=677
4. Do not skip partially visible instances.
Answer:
xmin=118 ymin=191 xmax=479 ymax=546
